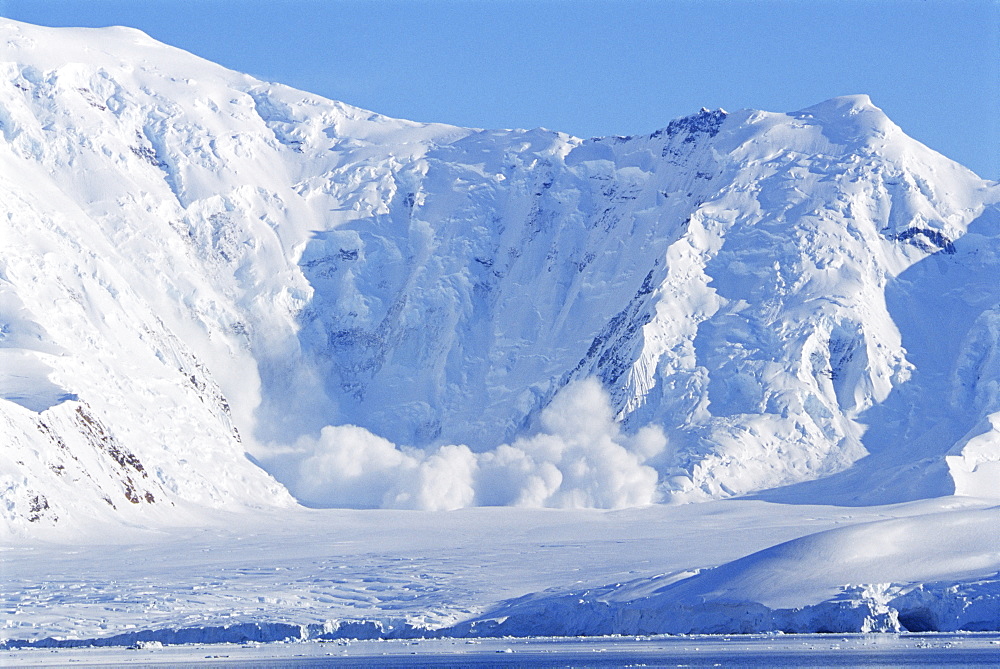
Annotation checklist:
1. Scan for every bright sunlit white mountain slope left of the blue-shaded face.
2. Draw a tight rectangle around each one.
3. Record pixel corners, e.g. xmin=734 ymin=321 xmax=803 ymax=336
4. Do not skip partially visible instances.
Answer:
xmin=0 ymin=21 xmax=468 ymax=523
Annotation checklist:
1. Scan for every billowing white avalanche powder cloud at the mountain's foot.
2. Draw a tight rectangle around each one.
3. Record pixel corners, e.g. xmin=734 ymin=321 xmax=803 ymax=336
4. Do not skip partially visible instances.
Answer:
xmin=288 ymin=379 xmax=667 ymax=510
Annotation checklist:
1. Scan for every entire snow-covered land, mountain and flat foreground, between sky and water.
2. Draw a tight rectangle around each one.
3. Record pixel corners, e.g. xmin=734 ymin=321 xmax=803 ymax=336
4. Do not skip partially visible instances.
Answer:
xmin=0 ymin=19 xmax=1000 ymax=648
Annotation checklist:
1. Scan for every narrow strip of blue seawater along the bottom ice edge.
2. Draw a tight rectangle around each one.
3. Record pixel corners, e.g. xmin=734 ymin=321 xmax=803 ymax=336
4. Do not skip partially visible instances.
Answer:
xmin=0 ymin=634 xmax=1000 ymax=667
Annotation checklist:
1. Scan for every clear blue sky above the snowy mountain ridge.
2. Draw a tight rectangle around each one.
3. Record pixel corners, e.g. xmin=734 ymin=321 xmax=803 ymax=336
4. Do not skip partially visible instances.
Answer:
xmin=0 ymin=0 xmax=1000 ymax=179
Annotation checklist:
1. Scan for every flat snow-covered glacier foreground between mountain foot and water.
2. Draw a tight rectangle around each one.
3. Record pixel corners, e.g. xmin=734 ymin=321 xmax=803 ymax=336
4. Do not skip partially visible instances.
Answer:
xmin=0 ymin=497 xmax=1000 ymax=648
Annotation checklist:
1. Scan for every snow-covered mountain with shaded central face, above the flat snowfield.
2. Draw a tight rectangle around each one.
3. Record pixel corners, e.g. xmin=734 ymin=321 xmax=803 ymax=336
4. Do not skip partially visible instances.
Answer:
xmin=0 ymin=20 xmax=1000 ymax=526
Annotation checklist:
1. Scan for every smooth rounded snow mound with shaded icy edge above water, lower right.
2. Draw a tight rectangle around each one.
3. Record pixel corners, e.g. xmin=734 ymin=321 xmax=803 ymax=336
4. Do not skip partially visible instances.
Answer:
xmin=456 ymin=507 xmax=1000 ymax=636
